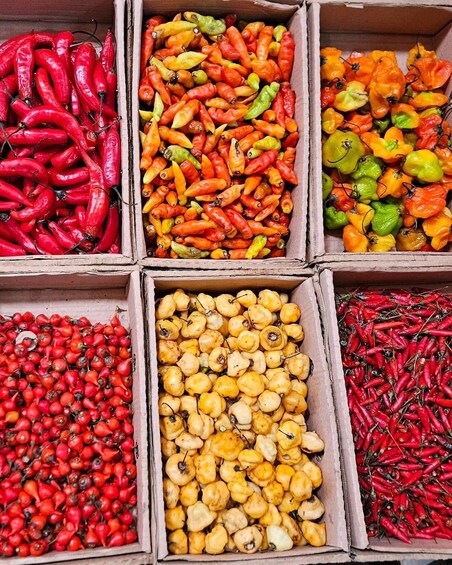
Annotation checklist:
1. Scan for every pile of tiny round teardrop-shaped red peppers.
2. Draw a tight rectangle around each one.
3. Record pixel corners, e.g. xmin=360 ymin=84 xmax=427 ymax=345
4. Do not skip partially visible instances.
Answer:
xmin=0 ymin=312 xmax=137 ymax=557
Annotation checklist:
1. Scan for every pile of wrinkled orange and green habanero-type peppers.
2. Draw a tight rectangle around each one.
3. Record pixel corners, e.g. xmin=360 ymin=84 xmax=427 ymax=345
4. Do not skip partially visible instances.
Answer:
xmin=320 ymin=43 xmax=452 ymax=252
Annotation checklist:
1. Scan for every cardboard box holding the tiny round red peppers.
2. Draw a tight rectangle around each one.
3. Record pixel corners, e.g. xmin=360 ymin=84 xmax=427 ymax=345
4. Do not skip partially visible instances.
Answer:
xmin=0 ymin=269 xmax=152 ymax=565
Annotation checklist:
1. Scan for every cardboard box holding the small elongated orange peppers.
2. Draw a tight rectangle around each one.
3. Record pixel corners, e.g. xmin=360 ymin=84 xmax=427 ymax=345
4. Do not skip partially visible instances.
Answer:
xmin=131 ymin=0 xmax=309 ymax=274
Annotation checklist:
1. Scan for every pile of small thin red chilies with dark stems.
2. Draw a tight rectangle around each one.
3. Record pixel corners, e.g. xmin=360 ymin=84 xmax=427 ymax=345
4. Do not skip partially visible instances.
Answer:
xmin=336 ymin=289 xmax=452 ymax=543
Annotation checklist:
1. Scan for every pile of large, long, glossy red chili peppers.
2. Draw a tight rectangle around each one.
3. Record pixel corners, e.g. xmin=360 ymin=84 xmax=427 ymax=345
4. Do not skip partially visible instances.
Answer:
xmin=0 ymin=31 xmax=121 ymax=253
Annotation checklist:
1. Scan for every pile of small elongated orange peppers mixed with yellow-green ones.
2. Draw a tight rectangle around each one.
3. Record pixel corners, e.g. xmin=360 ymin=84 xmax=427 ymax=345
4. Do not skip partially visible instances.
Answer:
xmin=138 ymin=12 xmax=298 ymax=259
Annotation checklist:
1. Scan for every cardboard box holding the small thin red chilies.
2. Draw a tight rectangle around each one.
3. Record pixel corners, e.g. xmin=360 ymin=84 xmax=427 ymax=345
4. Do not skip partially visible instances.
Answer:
xmin=319 ymin=263 xmax=452 ymax=561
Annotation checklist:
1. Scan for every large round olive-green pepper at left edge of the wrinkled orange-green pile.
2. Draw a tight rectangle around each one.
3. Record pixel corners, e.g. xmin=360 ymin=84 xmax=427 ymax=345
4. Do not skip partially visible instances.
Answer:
xmin=322 ymin=130 xmax=366 ymax=175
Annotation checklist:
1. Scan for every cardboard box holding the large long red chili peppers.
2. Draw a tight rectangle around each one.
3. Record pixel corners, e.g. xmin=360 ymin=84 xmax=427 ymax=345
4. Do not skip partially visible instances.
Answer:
xmin=0 ymin=0 xmax=135 ymax=272
